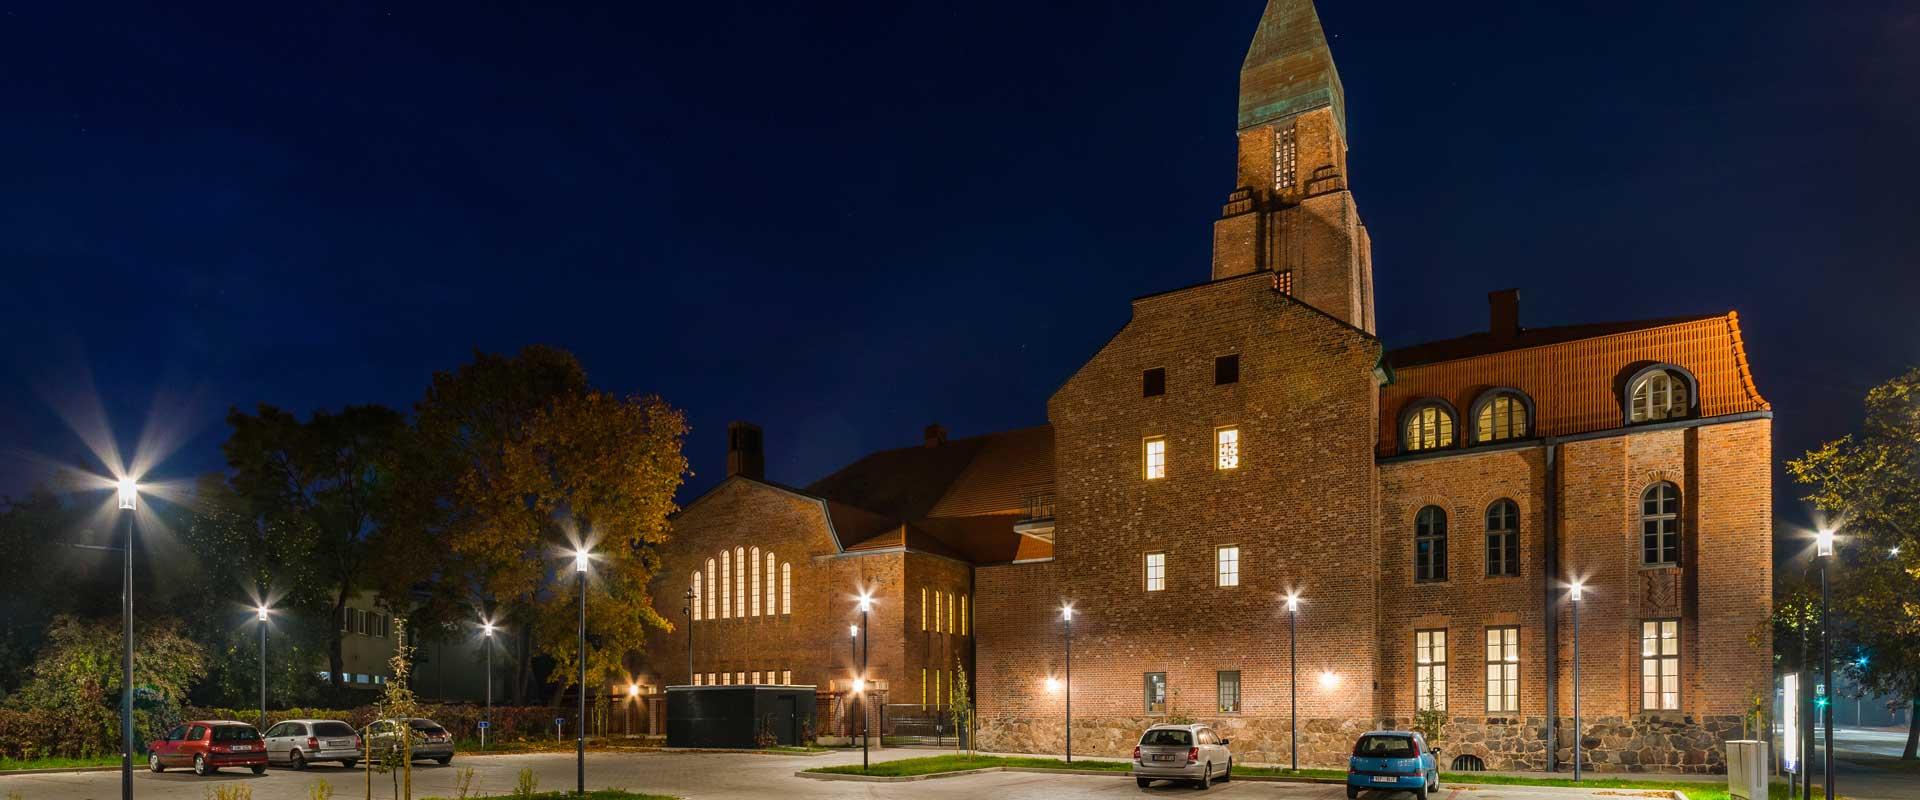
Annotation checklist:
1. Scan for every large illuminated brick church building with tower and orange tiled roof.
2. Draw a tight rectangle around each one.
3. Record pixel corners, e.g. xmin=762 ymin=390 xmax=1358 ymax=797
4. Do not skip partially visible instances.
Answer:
xmin=649 ymin=0 xmax=1772 ymax=771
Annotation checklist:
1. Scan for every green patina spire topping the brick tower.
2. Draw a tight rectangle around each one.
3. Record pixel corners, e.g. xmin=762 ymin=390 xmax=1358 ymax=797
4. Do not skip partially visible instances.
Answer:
xmin=1240 ymin=0 xmax=1346 ymax=134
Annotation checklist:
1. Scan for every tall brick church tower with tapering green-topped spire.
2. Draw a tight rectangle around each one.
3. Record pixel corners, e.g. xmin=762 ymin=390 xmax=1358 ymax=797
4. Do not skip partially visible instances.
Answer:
xmin=1213 ymin=0 xmax=1373 ymax=334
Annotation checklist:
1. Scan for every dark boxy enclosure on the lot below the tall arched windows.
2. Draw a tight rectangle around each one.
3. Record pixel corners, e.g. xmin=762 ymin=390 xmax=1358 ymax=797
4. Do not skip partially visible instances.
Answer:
xmin=666 ymin=685 xmax=814 ymax=748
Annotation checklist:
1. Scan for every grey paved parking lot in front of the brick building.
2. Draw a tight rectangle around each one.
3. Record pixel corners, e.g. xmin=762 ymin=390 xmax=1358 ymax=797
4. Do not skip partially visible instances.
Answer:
xmin=0 ymin=750 xmax=1666 ymax=800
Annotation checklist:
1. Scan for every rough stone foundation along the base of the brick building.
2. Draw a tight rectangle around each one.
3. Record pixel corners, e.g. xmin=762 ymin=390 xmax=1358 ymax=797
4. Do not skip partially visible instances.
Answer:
xmin=979 ymin=714 xmax=1743 ymax=773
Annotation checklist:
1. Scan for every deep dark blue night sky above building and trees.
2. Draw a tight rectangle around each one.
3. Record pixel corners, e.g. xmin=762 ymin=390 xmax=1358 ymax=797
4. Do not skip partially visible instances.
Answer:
xmin=0 ymin=0 xmax=1920 ymax=522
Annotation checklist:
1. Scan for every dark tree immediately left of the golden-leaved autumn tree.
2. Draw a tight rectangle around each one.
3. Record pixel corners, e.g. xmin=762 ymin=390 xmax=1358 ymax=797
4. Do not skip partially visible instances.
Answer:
xmin=221 ymin=405 xmax=405 ymax=689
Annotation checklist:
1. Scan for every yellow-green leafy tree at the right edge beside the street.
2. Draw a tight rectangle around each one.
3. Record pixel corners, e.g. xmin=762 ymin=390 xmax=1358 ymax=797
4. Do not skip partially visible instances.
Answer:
xmin=1788 ymin=370 xmax=1920 ymax=760
